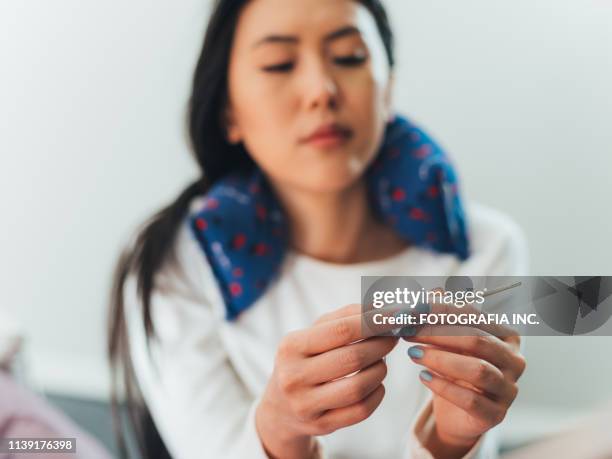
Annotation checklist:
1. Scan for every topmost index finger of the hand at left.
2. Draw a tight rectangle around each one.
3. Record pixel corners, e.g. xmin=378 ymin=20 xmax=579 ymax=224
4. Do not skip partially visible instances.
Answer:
xmin=294 ymin=308 xmax=398 ymax=356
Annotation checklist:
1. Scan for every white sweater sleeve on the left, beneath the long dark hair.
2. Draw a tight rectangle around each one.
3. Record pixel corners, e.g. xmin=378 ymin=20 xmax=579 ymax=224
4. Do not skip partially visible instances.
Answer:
xmin=124 ymin=224 xmax=268 ymax=459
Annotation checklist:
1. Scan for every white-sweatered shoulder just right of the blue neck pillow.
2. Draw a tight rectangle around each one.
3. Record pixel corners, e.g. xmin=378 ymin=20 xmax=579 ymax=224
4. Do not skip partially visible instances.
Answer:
xmin=465 ymin=201 xmax=529 ymax=276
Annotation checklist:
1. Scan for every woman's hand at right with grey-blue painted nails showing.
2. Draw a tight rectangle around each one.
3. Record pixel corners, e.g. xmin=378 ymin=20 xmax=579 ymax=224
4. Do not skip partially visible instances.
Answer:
xmin=403 ymin=305 xmax=526 ymax=457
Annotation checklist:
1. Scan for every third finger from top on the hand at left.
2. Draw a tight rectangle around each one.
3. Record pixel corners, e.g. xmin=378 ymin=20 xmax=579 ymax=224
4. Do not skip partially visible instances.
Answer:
xmin=306 ymin=360 xmax=387 ymax=414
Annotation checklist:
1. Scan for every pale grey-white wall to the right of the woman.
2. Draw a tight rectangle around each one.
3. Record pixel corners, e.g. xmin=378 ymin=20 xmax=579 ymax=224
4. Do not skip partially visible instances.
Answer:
xmin=389 ymin=0 xmax=612 ymax=420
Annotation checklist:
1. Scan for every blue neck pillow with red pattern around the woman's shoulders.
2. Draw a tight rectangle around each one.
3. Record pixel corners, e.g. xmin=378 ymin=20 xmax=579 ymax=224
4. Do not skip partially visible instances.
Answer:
xmin=189 ymin=116 xmax=469 ymax=320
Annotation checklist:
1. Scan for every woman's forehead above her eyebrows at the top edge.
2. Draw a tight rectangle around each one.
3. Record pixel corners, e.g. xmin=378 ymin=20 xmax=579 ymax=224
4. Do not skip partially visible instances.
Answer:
xmin=235 ymin=0 xmax=377 ymax=47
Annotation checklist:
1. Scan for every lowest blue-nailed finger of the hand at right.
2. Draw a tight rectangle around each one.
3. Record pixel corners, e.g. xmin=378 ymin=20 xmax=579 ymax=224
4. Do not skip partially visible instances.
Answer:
xmin=420 ymin=370 xmax=506 ymax=428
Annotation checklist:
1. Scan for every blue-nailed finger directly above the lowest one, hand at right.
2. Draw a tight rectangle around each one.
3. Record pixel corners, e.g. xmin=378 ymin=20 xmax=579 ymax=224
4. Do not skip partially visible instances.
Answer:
xmin=408 ymin=346 xmax=518 ymax=404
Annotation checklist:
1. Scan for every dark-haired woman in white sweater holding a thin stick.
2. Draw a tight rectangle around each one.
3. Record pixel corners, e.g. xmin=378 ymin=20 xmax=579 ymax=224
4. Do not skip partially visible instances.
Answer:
xmin=110 ymin=0 xmax=525 ymax=458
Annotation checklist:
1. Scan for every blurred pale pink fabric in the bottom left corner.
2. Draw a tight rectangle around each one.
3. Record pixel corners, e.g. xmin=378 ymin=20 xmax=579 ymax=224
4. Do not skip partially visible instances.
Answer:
xmin=0 ymin=371 xmax=111 ymax=459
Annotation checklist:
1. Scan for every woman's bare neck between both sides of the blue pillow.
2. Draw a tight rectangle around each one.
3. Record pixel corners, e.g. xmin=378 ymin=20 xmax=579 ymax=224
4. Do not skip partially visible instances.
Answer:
xmin=275 ymin=180 xmax=407 ymax=263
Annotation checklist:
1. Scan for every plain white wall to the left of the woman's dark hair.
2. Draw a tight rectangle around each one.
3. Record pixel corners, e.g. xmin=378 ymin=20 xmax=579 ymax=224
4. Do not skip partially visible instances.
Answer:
xmin=0 ymin=0 xmax=208 ymax=394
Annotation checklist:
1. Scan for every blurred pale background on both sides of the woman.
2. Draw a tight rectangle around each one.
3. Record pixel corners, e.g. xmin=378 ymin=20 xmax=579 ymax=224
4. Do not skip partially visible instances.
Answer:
xmin=0 ymin=0 xmax=612 ymax=458
